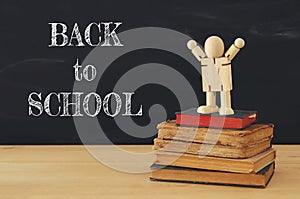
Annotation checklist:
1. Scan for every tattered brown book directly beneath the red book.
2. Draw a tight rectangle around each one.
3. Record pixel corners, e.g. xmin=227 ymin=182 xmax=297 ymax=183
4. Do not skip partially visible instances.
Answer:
xmin=157 ymin=120 xmax=274 ymax=147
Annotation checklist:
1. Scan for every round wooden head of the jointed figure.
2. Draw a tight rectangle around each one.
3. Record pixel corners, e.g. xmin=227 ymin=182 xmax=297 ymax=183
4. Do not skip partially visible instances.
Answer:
xmin=204 ymin=36 xmax=224 ymax=59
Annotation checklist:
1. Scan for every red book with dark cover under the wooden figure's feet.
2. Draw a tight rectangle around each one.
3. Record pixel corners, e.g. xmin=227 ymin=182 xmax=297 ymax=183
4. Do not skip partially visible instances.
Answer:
xmin=176 ymin=108 xmax=257 ymax=129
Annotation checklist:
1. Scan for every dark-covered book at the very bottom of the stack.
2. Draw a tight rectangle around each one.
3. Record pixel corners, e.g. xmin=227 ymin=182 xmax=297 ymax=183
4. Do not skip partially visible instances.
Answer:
xmin=150 ymin=163 xmax=275 ymax=187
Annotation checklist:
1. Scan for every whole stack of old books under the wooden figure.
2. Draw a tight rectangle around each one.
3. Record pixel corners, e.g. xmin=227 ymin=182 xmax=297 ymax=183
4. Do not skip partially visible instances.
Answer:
xmin=150 ymin=109 xmax=276 ymax=187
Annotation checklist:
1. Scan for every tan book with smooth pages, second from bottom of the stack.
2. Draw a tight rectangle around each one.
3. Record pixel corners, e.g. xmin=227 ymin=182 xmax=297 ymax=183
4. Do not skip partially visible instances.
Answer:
xmin=155 ymin=148 xmax=276 ymax=173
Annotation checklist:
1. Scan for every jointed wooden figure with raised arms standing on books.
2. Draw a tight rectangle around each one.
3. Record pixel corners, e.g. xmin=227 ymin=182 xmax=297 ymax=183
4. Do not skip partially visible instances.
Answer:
xmin=187 ymin=36 xmax=245 ymax=115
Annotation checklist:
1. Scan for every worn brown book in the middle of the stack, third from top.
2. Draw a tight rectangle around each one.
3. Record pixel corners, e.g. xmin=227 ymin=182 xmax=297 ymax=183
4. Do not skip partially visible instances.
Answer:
xmin=153 ymin=138 xmax=271 ymax=158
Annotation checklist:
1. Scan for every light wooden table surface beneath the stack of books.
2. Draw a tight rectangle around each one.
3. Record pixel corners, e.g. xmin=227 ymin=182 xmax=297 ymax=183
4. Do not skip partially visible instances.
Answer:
xmin=0 ymin=145 xmax=300 ymax=199
